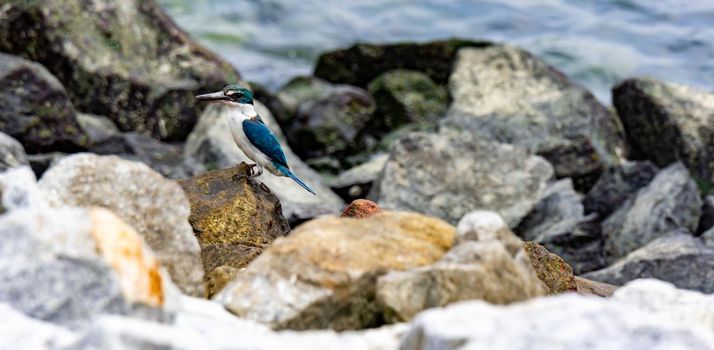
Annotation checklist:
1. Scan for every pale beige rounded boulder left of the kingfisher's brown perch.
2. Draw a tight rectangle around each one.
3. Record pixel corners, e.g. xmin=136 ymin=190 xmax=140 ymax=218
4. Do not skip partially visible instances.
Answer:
xmin=39 ymin=153 xmax=204 ymax=296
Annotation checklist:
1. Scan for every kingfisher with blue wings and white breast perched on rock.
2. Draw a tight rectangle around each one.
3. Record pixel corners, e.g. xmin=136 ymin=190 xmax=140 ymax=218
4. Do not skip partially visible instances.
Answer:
xmin=196 ymin=85 xmax=316 ymax=195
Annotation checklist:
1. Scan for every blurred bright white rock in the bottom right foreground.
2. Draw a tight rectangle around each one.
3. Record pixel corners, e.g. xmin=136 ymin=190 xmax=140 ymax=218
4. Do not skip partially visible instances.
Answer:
xmin=401 ymin=284 xmax=714 ymax=350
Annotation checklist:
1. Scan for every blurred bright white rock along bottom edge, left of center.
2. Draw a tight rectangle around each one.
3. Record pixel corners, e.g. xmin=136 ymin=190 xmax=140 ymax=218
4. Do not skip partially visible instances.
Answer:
xmin=75 ymin=297 xmax=406 ymax=350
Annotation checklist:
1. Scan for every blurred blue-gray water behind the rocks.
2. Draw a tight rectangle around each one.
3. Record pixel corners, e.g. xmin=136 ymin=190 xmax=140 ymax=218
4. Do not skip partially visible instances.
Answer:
xmin=159 ymin=0 xmax=714 ymax=104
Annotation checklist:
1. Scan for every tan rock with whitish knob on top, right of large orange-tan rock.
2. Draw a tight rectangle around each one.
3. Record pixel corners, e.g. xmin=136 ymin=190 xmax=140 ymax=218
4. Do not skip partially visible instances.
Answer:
xmin=377 ymin=210 xmax=548 ymax=322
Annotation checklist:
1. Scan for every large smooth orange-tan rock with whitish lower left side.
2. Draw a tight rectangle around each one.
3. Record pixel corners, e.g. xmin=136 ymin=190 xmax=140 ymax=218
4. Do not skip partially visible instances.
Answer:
xmin=213 ymin=212 xmax=455 ymax=330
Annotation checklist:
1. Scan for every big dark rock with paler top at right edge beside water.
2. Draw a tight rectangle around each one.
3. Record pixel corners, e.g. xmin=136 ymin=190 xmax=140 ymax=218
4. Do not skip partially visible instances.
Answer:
xmin=613 ymin=78 xmax=714 ymax=188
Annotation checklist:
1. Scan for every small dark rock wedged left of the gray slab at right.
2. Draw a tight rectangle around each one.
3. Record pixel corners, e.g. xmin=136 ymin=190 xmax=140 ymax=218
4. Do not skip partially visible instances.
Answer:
xmin=583 ymin=161 xmax=659 ymax=221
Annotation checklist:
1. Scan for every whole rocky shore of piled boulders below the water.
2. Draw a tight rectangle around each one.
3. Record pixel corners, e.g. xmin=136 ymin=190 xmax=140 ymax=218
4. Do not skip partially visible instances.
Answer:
xmin=0 ymin=0 xmax=714 ymax=350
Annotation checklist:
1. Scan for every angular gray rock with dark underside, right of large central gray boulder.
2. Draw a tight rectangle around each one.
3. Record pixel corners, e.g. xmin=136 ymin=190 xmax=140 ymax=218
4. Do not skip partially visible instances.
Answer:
xmin=515 ymin=179 xmax=605 ymax=274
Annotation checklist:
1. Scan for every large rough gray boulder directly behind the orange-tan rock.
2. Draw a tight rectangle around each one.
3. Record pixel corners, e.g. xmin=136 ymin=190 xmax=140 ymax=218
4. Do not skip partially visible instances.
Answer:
xmin=370 ymin=132 xmax=553 ymax=227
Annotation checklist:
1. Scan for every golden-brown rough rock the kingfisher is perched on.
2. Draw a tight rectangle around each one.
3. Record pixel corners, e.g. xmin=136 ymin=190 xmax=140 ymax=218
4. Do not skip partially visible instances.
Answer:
xmin=178 ymin=163 xmax=290 ymax=273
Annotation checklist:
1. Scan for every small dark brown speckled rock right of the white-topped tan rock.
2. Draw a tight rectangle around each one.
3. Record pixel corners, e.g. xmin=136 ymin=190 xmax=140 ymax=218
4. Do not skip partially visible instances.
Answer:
xmin=523 ymin=242 xmax=578 ymax=294
